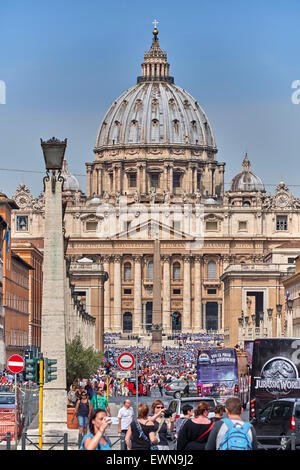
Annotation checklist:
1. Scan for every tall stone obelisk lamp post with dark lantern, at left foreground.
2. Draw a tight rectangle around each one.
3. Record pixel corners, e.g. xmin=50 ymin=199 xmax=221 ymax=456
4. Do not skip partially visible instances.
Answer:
xmin=41 ymin=137 xmax=67 ymax=433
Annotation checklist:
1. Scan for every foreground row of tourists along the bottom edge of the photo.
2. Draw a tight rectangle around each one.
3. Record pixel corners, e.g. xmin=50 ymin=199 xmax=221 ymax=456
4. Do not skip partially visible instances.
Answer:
xmin=77 ymin=397 xmax=257 ymax=451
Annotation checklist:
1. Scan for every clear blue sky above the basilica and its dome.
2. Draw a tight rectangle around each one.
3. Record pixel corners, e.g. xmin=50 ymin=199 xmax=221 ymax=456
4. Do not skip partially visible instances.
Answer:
xmin=0 ymin=0 xmax=300 ymax=197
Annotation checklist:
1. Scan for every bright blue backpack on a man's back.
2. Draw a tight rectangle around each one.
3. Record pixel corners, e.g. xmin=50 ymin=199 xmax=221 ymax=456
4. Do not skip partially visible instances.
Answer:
xmin=218 ymin=418 xmax=252 ymax=450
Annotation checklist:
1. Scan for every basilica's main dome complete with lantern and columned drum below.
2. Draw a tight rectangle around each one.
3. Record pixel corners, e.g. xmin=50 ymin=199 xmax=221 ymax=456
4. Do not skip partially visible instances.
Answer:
xmin=86 ymin=29 xmax=225 ymax=201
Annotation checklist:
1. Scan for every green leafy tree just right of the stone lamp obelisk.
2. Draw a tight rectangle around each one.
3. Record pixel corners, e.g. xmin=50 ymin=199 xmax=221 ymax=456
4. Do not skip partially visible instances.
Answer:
xmin=66 ymin=336 xmax=103 ymax=389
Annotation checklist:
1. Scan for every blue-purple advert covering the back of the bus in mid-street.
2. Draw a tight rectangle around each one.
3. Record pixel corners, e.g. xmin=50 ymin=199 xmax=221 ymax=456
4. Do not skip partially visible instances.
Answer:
xmin=197 ymin=348 xmax=238 ymax=396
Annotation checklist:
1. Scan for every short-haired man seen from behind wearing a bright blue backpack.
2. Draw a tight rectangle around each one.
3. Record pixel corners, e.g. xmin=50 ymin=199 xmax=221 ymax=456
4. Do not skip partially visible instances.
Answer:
xmin=205 ymin=397 xmax=257 ymax=450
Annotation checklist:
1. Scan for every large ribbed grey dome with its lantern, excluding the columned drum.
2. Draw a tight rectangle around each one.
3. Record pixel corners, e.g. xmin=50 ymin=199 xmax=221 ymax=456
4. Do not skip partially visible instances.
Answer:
xmin=95 ymin=29 xmax=216 ymax=148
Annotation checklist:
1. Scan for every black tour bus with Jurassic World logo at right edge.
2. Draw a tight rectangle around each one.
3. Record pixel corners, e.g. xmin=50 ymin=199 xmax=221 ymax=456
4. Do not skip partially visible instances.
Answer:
xmin=249 ymin=338 xmax=300 ymax=419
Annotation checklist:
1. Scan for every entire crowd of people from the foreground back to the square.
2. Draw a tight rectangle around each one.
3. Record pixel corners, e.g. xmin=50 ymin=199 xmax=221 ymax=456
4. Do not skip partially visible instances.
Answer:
xmin=68 ymin=335 xmax=257 ymax=451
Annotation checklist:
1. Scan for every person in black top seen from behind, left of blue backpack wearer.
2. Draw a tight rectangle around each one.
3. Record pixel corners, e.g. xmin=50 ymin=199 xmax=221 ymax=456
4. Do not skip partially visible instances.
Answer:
xmin=177 ymin=401 xmax=215 ymax=450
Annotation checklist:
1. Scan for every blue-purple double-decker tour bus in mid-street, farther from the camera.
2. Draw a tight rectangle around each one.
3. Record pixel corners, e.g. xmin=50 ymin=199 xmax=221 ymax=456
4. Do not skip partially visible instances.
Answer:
xmin=197 ymin=348 xmax=249 ymax=407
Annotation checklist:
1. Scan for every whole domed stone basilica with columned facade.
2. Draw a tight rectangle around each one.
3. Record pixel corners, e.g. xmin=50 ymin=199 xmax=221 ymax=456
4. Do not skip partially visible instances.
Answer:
xmin=12 ymin=29 xmax=300 ymax=345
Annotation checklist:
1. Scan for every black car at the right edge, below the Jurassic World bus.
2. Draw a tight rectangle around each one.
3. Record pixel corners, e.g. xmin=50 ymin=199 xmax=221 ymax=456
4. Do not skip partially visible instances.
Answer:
xmin=251 ymin=398 xmax=300 ymax=450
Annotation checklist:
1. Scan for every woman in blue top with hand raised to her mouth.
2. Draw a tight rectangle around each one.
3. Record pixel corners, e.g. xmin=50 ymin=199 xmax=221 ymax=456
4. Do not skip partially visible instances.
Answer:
xmin=80 ymin=410 xmax=111 ymax=450
